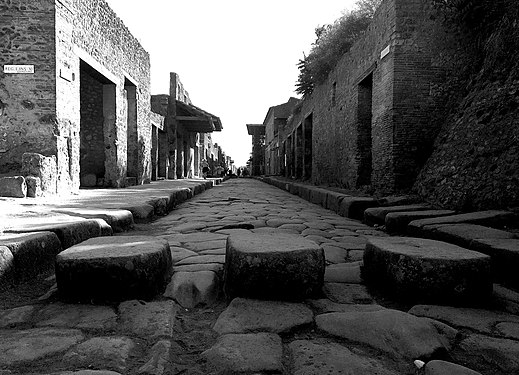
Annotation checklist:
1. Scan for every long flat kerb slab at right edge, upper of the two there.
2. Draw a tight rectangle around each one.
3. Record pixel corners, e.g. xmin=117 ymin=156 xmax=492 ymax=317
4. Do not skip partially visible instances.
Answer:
xmin=407 ymin=210 xmax=517 ymax=237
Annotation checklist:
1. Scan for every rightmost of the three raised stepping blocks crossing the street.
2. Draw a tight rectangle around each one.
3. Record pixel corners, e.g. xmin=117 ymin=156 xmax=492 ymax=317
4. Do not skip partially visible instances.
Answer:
xmin=363 ymin=237 xmax=492 ymax=304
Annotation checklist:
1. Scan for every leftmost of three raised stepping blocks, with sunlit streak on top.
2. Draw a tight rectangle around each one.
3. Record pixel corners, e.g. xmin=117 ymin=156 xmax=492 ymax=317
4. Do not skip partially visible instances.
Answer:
xmin=56 ymin=236 xmax=172 ymax=301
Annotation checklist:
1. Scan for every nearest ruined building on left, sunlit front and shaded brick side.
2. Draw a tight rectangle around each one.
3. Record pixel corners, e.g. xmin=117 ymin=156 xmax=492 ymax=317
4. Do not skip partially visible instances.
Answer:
xmin=0 ymin=0 xmax=151 ymax=193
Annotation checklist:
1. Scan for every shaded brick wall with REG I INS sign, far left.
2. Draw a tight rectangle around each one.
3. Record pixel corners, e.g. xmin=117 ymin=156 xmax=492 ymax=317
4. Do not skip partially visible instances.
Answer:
xmin=0 ymin=0 xmax=56 ymax=175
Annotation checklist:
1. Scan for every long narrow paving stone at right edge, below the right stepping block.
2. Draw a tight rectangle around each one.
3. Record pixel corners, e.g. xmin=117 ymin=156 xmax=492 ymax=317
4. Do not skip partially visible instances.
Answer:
xmin=409 ymin=305 xmax=519 ymax=334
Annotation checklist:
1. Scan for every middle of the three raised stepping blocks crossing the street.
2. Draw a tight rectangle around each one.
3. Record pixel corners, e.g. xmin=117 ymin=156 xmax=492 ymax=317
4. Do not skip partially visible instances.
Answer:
xmin=224 ymin=233 xmax=325 ymax=300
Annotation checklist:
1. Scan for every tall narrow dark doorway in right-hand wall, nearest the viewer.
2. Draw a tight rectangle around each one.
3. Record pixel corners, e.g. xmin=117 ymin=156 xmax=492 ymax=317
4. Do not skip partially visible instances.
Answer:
xmin=357 ymin=73 xmax=373 ymax=187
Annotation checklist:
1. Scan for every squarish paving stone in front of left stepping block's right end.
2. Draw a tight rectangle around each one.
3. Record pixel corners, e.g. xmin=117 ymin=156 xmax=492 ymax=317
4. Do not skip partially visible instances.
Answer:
xmin=118 ymin=300 xmax=178 ymax=338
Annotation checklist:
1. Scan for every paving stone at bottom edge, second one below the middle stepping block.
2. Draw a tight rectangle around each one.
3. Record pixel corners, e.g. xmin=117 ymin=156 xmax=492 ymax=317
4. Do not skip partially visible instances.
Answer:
xmin=202 ymin=333 xmax=283 ymax=373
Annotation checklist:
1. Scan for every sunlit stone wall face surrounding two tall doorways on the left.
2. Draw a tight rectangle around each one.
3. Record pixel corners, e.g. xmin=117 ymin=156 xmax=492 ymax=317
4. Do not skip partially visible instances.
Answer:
xmin=56 ymin=0 xmax=151 ymax=187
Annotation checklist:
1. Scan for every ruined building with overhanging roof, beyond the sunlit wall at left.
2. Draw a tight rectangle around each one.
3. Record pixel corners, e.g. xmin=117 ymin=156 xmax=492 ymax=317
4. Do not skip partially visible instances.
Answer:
xmin=151 ymin=73 xmax=222 ymax=179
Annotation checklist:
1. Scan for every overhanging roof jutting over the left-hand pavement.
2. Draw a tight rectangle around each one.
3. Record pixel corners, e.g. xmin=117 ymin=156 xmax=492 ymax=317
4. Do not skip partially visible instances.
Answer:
xmin=175 ymin=100 xmax=223 ymax=133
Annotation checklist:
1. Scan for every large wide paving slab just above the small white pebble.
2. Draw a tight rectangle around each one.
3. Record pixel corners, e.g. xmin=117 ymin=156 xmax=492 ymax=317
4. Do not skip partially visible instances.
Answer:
xmin=316 ymin=309 xmax=457 ymax=360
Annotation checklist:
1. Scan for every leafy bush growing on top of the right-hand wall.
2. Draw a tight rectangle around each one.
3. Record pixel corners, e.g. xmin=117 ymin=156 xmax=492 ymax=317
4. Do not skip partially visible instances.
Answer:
xmin=296 ymin=0 xmax=382 ymax=96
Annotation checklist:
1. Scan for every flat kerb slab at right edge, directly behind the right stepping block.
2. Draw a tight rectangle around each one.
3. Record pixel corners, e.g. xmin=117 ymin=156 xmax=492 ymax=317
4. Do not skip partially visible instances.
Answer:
xmin=412 ymin=223 xmax=516 ymax=250
